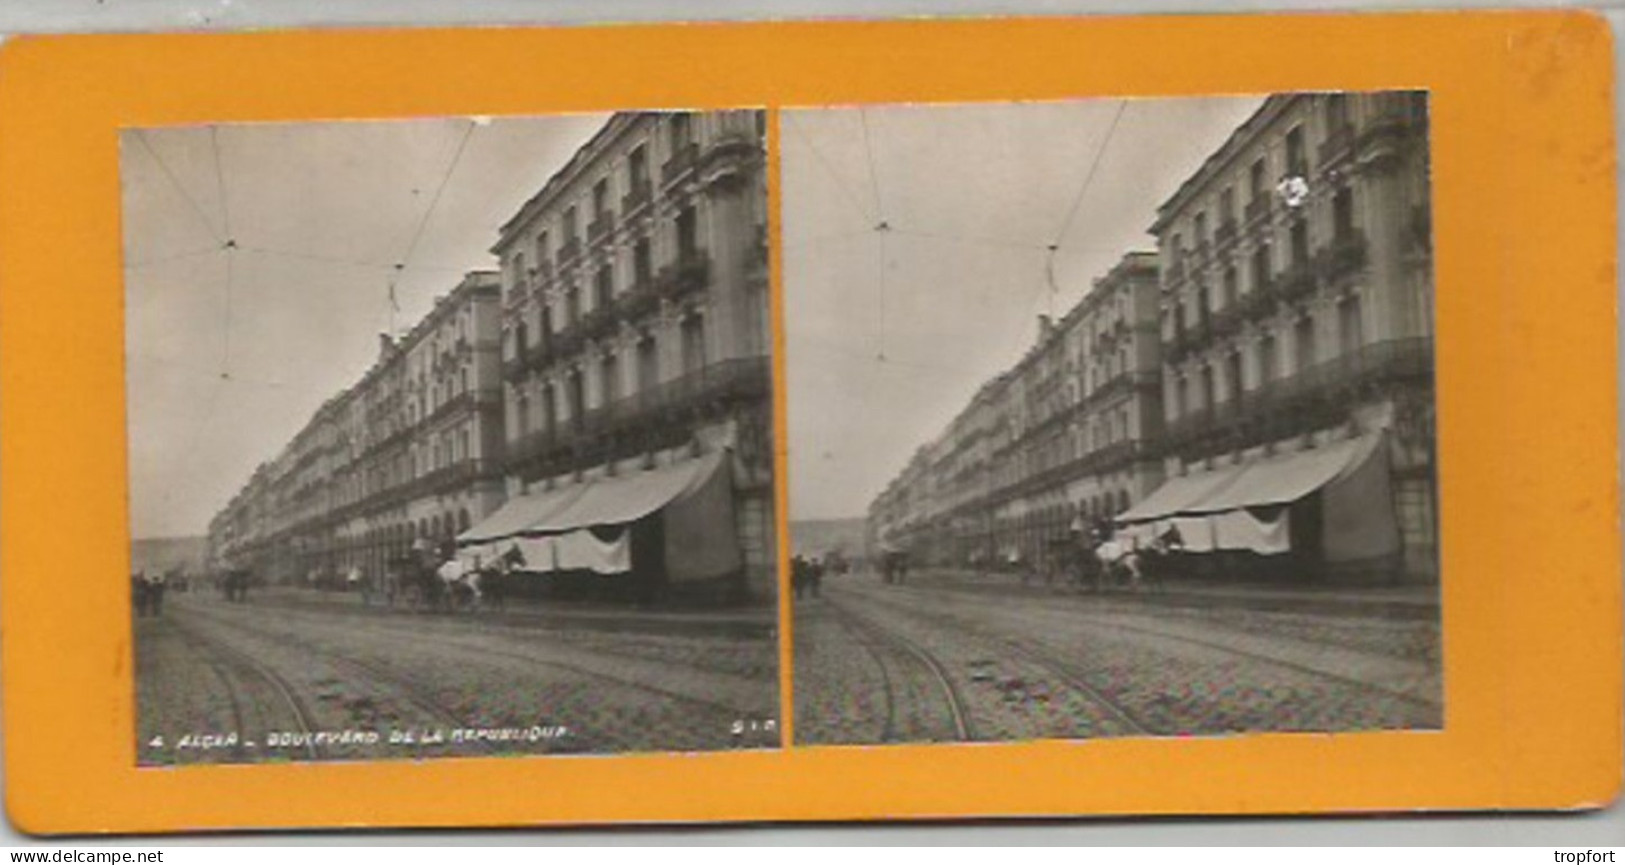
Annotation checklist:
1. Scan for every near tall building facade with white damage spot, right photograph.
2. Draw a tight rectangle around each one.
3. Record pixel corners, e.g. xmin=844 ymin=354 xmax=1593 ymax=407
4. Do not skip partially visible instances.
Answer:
xmin=1129 ymin=93 xmax=1437 ymax=574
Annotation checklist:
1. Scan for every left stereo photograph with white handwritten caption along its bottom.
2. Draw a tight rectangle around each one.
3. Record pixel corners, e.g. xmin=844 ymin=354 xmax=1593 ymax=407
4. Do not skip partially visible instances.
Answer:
xmin=123 ymin=111 xmax=782 ymax=766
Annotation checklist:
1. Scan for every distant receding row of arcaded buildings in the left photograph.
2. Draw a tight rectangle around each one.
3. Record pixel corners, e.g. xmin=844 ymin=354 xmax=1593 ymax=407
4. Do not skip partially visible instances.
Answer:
xmin=210 ymin=273 xmax=505 ymax=582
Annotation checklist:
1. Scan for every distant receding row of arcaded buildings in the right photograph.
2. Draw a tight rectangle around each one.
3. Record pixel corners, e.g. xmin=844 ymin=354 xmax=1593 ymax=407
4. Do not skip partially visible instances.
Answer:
xmin=869 ymin=252 xmax=1162 ymax=566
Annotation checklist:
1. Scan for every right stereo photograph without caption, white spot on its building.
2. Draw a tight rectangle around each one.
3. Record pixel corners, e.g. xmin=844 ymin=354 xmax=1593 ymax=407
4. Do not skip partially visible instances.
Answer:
xmin=778 ymin=91 xmax=1445 ymax=745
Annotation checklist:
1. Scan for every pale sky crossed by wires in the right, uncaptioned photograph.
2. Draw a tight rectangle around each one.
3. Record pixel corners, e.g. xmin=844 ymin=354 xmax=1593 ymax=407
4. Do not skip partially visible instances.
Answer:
xmin=780 ymin=98 xmax=1263 ymax=519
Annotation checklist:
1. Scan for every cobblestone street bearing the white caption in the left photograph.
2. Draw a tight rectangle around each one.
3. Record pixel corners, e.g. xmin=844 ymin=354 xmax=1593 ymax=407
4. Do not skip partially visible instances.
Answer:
xmin=135 ymin=592 xmax=778 ymax=766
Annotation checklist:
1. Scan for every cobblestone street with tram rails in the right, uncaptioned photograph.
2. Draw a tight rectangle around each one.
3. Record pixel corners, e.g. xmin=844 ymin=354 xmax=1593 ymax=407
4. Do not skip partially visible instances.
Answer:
xmin=795 ymin=574 xmax=1443 ymax=745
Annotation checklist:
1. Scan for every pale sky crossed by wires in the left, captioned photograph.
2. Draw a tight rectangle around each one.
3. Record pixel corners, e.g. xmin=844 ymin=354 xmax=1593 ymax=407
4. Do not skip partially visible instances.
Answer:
xmin=122 ymin=115 xmax=608 ymax=538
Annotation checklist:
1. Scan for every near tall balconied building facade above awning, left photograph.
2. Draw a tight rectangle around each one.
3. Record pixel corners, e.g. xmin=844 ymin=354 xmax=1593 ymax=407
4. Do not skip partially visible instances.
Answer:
xmin=492 ymin=111 xmax=777 ymax=595
